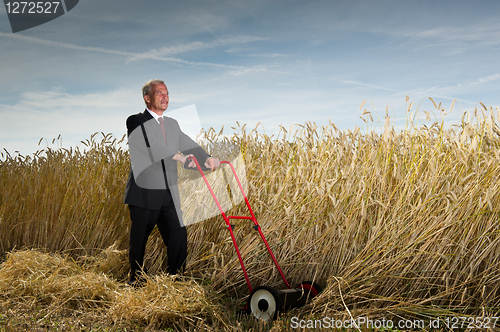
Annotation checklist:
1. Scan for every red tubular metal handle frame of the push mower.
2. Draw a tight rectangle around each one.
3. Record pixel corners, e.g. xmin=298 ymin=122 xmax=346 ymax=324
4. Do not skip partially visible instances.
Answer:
xmin=188 ymin=156 xmax=292 ymax=292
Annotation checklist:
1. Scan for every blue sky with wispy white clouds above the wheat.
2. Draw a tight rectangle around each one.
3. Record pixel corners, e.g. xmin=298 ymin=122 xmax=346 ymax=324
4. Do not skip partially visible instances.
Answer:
xmin=0 ymin=0 xmax=500 ymax=154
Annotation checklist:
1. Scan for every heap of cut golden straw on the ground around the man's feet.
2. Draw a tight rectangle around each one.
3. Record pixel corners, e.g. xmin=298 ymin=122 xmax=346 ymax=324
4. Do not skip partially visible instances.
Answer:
xmin=0 ymin=250 xmax=223 ymax=327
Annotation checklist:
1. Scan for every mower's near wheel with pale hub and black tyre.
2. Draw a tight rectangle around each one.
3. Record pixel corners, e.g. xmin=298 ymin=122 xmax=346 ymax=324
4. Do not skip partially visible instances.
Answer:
xmin=248 ymin=286 xmax=283 ymax=321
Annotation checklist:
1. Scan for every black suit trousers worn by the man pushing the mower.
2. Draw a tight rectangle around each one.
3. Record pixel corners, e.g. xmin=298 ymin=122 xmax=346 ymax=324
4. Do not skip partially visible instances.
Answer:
xmin=129 ymin=195 xmax=187 ymax=281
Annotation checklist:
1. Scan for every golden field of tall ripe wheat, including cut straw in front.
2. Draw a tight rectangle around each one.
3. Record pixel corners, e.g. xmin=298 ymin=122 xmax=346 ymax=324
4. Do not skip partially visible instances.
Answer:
xmin=0 ymin=99 xmax=500 ymax=331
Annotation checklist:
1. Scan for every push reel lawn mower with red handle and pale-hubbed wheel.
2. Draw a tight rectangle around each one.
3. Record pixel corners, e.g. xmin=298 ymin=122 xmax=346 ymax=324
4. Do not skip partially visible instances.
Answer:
xmin=188 ymin=156 xmax=322 ymax=321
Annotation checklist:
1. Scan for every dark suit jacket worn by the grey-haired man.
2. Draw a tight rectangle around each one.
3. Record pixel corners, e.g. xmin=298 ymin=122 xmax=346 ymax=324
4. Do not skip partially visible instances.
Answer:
xmin=124 ymin=110 xmax=210 ymax=211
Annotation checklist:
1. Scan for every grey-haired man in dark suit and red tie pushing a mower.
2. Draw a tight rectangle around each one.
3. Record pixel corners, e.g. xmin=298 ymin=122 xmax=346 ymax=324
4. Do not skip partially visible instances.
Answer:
xmin=124 ymin=80 xmax=220 ymax=286
